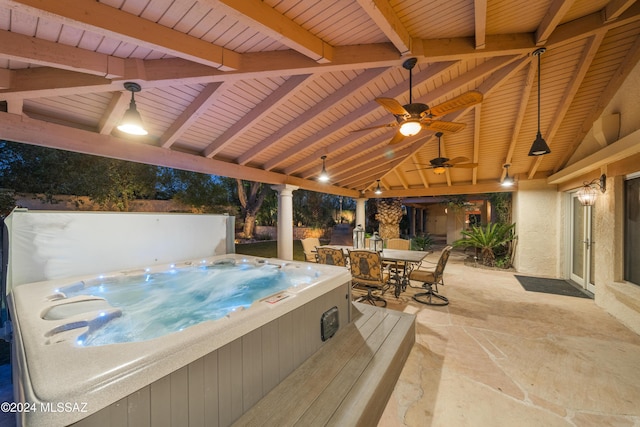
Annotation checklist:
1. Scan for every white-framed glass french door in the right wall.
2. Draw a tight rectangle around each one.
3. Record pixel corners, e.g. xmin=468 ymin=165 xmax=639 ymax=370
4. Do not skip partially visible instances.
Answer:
xmin=570 ymin=193 xmax=596 ymax=293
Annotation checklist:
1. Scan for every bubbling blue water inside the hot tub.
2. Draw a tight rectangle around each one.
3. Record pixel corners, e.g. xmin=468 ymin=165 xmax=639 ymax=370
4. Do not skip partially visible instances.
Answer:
xmin=57 ymin=259 xmax=320 ymax=346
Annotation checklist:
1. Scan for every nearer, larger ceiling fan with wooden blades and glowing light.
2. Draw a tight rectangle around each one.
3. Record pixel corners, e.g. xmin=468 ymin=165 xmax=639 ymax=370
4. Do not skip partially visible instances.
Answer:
xmin=358 ymin=58 xmax=482 ymax=144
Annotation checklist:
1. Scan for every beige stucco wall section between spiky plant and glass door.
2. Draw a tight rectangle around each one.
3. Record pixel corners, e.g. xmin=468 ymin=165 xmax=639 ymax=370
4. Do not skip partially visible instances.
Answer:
xmin=513 ymin=180 xmax=561 ymax=277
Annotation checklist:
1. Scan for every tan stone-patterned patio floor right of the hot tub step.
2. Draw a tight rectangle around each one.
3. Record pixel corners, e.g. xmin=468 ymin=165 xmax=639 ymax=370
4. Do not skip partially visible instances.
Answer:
xmin=379 ymin=252 xmax=640 ymax=427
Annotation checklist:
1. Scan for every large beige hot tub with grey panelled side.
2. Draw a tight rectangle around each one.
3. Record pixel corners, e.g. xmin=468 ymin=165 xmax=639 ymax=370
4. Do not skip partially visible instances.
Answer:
xmin=10 ymin=254 xmax=351 ymax=426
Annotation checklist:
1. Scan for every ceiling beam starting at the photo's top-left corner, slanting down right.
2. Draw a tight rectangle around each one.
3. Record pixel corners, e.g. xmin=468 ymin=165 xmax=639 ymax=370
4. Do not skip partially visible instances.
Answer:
xmin=3 ymin=0 xmax=244 ymax=70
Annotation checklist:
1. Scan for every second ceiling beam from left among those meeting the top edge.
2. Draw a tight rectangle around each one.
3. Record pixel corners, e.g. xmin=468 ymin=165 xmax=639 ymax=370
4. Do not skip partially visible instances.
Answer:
xmin=215 ymin=0 xmax=333 ymax=63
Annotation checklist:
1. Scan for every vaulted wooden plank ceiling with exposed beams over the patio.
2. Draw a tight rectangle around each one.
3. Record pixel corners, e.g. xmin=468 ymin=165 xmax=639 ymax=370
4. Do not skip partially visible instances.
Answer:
xmin=0 ymin=0 xmax=640 ymax=201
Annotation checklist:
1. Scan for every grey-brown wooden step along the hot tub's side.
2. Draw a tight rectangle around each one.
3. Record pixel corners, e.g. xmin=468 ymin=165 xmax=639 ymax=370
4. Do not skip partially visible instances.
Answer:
xmin=234 ymin=303 xmax=415 ymax=426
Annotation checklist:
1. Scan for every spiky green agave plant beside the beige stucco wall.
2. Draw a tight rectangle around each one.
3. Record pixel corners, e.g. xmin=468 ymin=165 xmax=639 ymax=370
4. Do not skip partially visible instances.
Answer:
xmin=453 ymin=223 xmax=516 ymax=267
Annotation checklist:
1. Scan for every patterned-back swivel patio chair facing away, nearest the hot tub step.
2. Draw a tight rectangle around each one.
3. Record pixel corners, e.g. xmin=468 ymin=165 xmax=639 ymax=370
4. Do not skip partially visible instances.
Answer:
xmin=349 ymin=249 xmax=389 ymax=307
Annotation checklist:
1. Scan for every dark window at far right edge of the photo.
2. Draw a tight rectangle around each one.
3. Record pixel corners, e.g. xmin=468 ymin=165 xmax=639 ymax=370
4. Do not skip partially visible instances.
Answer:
xmin=624 ymin=178 xmax=640 ymax=285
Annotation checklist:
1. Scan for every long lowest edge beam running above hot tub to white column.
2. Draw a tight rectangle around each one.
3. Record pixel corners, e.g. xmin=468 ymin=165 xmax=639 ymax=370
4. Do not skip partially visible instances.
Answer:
xmin=0 ymin=112 xmax=360 ymax=198
